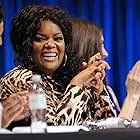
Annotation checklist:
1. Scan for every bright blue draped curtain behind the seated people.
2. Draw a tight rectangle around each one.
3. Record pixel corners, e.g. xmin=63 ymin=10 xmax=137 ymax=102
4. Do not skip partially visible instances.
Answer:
xmin=0 ymin=0 xmax=140 ymax=105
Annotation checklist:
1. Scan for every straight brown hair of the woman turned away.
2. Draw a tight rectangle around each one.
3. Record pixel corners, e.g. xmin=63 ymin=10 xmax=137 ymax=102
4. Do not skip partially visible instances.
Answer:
xmin=72 ymin=18 xmax=101 ymax=62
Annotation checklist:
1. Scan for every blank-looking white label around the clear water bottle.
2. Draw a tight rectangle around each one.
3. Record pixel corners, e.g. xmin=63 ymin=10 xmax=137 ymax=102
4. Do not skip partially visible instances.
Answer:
xmin=29 ymin=94 xmax=47 ymax=110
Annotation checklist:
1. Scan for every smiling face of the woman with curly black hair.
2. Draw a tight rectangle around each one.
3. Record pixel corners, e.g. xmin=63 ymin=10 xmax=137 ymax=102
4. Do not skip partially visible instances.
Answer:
xmin=33 ymin=20 xmax=65 ymax=76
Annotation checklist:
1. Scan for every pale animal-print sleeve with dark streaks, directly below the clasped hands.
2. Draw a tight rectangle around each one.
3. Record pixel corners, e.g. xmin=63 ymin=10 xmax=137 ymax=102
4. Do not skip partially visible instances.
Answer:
xmin=55 ymin=85 xmax=90 ymax=125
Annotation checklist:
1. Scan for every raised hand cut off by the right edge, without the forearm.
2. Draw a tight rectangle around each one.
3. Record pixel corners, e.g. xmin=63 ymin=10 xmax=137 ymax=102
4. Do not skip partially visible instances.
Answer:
xmin=126 ymin=61 xmax=140 ymax=98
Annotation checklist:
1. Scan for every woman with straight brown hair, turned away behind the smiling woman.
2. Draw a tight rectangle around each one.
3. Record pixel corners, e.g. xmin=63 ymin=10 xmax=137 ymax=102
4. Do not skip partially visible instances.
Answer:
xmin=72 ymin=18 xmax=120 ymax=115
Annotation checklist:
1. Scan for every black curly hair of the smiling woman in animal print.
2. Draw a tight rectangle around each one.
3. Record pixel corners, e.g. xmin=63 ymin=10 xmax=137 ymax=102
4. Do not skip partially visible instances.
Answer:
xmin=10 ymin=5 xmax=79 ymax=87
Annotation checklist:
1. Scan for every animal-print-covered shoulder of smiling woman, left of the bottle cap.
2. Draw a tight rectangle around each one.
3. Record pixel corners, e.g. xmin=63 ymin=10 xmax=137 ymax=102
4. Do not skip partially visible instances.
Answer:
xmin=0 ymin=66 xmax=32 ymax=100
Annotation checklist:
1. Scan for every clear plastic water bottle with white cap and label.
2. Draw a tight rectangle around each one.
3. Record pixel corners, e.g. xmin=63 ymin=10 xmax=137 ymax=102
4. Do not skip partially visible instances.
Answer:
xmin=29 ymin=75 xmax=47 ymax=133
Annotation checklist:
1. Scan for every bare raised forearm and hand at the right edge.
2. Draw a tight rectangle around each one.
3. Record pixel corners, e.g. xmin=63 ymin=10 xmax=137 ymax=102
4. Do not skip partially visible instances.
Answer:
xmin=119 ymin=61 xmax=140 ymax=121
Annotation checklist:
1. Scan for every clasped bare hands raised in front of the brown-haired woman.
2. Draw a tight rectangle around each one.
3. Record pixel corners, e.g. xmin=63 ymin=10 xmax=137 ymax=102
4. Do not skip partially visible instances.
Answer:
xmin=71 ymin=53 xmax=109 ymax=93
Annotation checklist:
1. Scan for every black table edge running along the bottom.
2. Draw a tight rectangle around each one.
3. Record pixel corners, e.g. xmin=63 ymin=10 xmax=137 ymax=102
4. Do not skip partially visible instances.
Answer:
xmin=0 ymin=128 xmax=140 ymax=140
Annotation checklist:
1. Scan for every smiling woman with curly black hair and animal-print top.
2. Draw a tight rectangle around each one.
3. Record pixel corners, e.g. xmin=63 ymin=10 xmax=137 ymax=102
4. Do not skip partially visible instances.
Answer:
xmin=0 ymin=5 xmax=114 ymax=129
